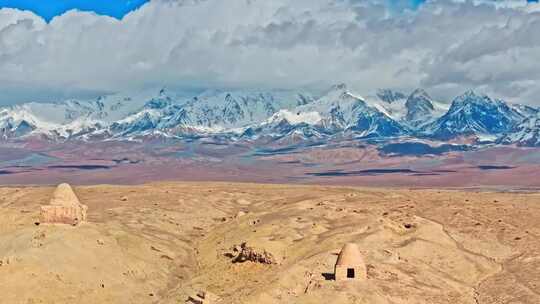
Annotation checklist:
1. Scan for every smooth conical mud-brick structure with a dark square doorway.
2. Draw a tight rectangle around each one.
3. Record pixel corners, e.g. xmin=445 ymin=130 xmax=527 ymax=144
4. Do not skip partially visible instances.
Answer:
xmin=334 ymin=243 xmax=367 ymax=281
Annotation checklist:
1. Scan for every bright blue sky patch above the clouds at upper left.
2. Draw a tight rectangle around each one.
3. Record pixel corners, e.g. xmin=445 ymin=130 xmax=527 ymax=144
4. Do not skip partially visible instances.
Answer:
xmin=0 ymin=0 xmax=148 ymax=21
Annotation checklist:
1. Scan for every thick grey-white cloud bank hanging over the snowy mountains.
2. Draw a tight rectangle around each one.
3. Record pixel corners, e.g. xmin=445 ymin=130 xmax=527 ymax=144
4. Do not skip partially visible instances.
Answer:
xmin=0 ymin=0 xmax=540 ymax=104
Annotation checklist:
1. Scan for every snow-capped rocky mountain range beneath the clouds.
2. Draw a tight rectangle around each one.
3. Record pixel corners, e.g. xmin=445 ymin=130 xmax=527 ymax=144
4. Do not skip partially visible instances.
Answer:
xmin=0 ymin=84 xmax=540 ymax=146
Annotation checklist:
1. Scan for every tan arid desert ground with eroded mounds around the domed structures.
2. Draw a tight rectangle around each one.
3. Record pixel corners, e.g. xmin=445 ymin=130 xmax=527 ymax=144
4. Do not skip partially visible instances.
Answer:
xmin=0 ymin=182 xmax=540 ymax=304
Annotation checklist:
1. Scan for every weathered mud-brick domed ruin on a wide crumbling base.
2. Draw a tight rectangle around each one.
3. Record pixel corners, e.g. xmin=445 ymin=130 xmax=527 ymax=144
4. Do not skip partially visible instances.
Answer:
xmin=41 ymin=184 xmax=88 ymax=225
